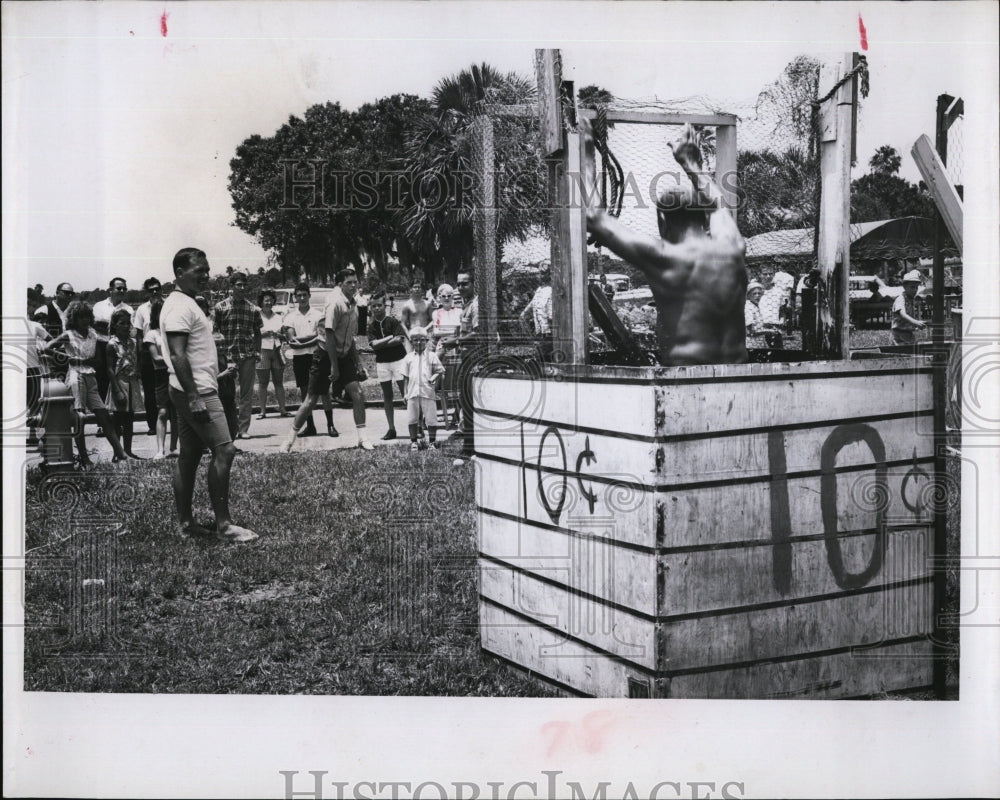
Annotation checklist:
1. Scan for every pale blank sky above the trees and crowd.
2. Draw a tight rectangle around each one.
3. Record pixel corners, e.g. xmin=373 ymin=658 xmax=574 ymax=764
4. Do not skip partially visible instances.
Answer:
xmin=3 ymin=2 xmax=997 ymax=296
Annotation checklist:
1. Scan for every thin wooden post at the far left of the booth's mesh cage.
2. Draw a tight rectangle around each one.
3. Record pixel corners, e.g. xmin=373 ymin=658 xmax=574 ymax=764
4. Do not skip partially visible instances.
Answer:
xmin=472 ymin=116 xmax=498 ymax=353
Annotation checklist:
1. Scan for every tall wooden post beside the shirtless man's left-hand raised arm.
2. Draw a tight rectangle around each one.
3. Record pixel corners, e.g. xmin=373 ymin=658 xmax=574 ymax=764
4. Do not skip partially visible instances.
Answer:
xmin=535 ymin=50 xmax=589 ymax=364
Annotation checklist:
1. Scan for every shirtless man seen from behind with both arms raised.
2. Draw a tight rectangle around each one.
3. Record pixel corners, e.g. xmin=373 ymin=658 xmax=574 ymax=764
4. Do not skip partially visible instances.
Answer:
xmin=583 ymin=120 xmax=747 ymax=367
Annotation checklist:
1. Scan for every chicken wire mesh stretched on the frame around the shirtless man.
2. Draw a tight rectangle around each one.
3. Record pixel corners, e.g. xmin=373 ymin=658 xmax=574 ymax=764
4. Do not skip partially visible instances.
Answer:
xmin=490 ymin=56 xmax=844 ymax=350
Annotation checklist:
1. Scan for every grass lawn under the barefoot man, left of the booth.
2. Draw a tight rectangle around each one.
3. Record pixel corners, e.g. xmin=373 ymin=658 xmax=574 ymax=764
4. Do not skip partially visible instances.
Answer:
xmin=19 ymin=448 xmax=551 ymax=697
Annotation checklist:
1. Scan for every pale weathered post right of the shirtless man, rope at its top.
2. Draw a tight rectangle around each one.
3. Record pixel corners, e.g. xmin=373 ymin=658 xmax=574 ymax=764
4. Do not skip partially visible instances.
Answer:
xmin=816 ymin=53 xmax=857 ymax=358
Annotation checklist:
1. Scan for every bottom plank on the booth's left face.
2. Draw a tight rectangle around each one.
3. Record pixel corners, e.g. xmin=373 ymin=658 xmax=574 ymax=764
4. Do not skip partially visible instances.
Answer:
xmin=479 ymin=600 xmax=655 ymax=697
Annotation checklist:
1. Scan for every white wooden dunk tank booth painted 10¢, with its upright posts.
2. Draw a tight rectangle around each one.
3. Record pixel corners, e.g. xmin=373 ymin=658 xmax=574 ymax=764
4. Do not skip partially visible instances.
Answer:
xmin=473 ymin=51 xmax=941 ymax=698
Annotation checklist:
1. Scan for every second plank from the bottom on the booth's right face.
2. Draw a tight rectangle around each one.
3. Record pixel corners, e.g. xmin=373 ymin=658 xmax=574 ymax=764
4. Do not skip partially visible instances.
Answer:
xmin=659 ymin=581 xmax=933 ymax=670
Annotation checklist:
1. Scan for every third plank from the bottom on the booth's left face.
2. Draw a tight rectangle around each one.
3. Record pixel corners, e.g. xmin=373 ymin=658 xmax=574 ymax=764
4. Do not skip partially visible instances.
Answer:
xmin=479 ymin=514 xmax=657 ymax=624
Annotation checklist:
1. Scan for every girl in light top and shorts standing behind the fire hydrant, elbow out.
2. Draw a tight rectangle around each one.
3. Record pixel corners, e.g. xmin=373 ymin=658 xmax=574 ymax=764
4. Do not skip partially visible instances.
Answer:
xmin=43 ymin=300 xmax=128 ymax=467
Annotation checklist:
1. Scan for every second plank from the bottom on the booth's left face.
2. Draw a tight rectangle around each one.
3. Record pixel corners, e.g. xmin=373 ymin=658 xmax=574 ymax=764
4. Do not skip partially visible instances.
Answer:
xmin=479 ymin=562 xmax=656 ymax=670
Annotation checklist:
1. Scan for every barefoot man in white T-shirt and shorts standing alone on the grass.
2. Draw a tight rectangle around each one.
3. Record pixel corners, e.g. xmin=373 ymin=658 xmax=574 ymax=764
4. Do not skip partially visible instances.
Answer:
xmin=160 ymin=247 xmax=258 ymax=542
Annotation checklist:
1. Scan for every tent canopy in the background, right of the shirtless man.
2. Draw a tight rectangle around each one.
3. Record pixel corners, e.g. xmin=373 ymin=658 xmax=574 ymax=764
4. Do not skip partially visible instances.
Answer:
xmin=746 ymin=217 xmax=958 ymax=261
